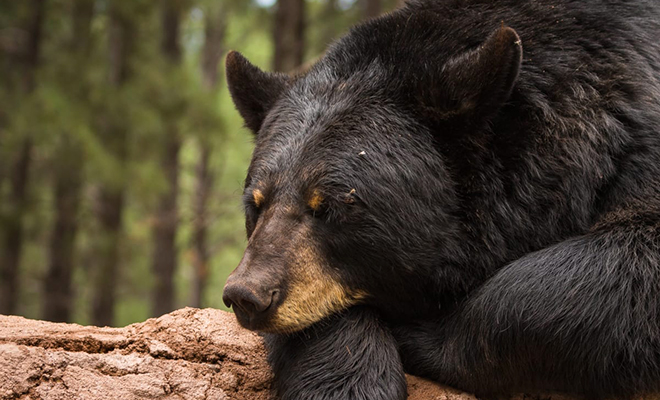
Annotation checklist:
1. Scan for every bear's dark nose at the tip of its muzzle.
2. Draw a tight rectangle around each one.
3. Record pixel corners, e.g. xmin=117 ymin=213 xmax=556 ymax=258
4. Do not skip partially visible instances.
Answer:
xmin=222 ymin=282 xmax=279 ymax=321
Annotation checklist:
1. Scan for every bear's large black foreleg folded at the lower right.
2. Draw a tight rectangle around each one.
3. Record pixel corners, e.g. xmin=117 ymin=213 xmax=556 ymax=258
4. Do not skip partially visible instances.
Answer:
xmin=393 ymin=209 xmax=660 ymax=399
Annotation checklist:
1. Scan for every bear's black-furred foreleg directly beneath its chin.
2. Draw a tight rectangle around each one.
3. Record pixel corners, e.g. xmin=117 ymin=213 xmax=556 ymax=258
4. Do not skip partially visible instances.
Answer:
xmin=265 ymin=307 xmax=407 ymax=400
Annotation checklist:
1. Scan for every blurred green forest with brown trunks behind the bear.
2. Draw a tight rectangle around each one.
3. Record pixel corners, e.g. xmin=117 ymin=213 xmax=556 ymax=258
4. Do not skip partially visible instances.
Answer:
xmin=0 ymin=0 xmax=400 ymax=326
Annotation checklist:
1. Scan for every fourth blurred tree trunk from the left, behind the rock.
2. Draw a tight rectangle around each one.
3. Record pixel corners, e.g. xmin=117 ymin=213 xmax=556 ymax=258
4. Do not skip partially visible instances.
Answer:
xmin=152 ymin=0 xmax=182 ymax=316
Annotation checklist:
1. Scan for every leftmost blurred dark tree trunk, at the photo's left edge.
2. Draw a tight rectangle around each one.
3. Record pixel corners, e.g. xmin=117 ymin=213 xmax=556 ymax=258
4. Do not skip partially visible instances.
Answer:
xmin=0 ymin=0 xmax=46 ymax=314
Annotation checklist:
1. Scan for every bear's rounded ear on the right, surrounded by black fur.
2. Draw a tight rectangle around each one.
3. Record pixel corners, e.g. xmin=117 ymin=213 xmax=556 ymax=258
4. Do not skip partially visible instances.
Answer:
xmin=421 ymin=26 xmax=522 ymax=122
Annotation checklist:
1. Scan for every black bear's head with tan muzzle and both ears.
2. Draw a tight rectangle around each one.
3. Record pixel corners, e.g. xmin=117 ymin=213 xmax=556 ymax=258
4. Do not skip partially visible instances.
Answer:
xmin=223 ymin=20 xmax=521 ymax=333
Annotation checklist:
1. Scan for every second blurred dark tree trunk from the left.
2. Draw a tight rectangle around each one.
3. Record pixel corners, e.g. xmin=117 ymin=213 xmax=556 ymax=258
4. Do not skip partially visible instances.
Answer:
xmin=43 ymin=0 xmax=94 ymax=322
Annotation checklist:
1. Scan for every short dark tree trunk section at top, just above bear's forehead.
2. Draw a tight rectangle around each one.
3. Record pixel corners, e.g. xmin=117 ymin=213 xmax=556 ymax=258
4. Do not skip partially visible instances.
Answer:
xmin=273 ymin=0 xmax=305 ymax=72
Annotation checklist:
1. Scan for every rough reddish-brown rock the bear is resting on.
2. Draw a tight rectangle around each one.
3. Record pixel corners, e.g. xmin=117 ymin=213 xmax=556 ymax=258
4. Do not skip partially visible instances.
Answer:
xmin=0 ymin=308 xmax=558 ymax=400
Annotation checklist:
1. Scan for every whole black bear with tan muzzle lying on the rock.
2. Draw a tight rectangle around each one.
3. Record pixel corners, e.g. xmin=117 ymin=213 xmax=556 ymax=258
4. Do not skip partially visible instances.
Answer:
xmin=224 ymin=0 xmax=660 ymax=400
